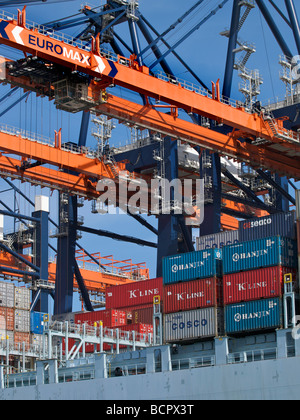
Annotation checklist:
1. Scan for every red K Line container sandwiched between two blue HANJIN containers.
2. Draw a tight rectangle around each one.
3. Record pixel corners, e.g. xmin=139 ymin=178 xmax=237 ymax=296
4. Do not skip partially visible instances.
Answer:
xmin=223 ymin=266 xmax=296 ymax=305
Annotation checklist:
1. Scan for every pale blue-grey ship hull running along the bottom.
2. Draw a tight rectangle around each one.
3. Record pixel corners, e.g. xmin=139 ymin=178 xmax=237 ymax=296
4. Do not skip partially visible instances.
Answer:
xmin=0 ymin=342 xmax=300 ymax=405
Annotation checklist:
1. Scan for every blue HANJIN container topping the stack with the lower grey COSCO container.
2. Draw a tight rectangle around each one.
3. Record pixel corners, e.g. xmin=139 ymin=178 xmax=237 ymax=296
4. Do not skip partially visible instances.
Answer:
xmin=163 ymin=249 xmax=222 ymax=284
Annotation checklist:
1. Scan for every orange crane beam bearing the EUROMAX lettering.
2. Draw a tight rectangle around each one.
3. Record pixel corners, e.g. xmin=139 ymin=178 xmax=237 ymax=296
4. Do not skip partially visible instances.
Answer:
xmin=0 ymin=10 xmax=298 ymax=149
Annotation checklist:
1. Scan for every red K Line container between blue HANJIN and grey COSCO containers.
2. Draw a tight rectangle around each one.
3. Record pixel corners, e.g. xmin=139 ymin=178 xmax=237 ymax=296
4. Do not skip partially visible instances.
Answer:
xmin=164 ymin=277 xmax=222 ymax=314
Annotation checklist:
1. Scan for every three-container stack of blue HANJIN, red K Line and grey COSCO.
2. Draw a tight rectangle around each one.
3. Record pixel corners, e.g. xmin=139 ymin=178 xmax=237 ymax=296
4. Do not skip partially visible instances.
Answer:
xmin=163 ymin=249 xmax=223 ymax=342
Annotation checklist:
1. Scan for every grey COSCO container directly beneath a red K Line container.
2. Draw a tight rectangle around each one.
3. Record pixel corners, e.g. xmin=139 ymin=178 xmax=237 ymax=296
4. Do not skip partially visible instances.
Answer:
xmin=164 ymin=307 xmax=224 ymax=343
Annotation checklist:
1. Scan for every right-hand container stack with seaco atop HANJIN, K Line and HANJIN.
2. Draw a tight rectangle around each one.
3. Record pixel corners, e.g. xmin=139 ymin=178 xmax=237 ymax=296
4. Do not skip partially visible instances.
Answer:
xmin=223 ymin=230 xmax=297 ymax=334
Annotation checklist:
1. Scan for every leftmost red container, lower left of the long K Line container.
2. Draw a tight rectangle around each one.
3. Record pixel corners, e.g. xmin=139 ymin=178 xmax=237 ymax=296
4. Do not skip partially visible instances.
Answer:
xmin=75 ymin=309 xmax=131 ymax=327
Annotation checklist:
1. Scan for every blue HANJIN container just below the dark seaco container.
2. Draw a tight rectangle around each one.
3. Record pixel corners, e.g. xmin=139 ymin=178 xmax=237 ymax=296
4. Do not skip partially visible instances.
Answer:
xmin=222 ymin=236 xmax=297 ymax=274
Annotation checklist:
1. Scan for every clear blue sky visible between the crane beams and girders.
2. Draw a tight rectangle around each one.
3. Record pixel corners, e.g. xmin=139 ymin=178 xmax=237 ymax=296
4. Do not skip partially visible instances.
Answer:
xmin=0 ymin=0 xmax=300 ymax=312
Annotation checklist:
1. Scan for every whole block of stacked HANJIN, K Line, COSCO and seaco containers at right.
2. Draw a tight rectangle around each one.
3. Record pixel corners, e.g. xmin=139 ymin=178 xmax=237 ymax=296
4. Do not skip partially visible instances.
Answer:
xmin=163 ymin=212 xmax=297 ymax=342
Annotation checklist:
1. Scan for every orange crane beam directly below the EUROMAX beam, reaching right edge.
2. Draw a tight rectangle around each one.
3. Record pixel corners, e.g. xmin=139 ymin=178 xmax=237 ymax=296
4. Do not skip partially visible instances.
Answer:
xmin=95 ymin=95 xmax=300 ymax=179
